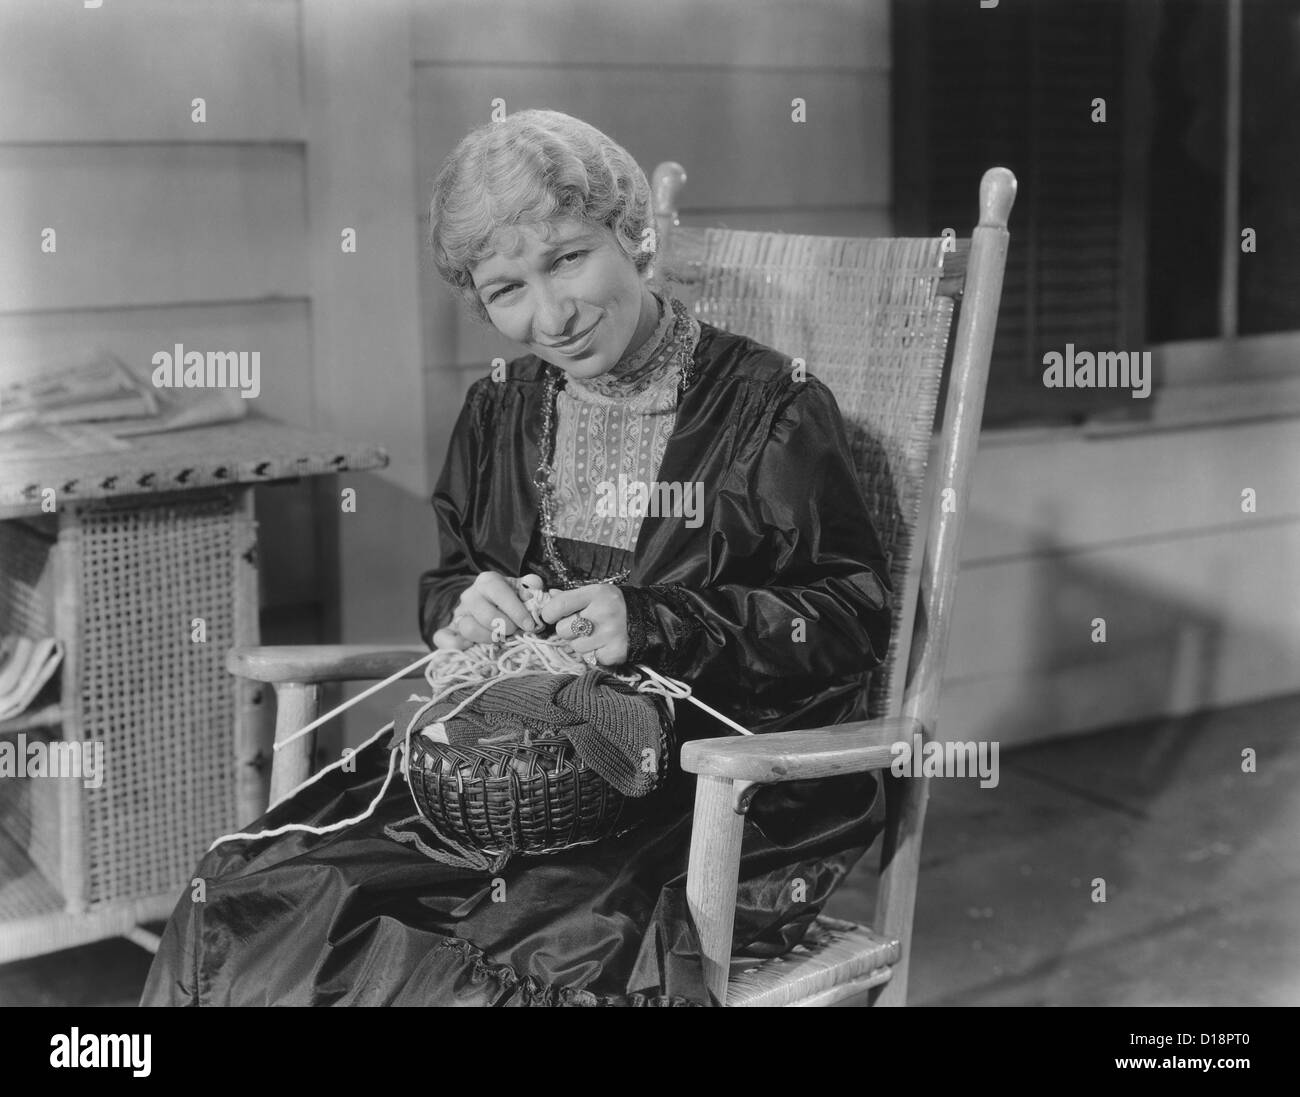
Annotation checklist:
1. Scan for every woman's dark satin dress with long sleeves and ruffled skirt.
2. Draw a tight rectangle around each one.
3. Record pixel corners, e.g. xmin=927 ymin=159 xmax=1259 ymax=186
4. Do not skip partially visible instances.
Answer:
xmin=142 ymin=325 xmax=891 ymax=1006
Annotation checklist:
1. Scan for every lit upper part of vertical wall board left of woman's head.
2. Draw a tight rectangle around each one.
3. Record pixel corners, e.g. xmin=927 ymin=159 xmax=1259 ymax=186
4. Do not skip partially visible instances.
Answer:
xmin=300 ymin=0 xmax=426 ymax=497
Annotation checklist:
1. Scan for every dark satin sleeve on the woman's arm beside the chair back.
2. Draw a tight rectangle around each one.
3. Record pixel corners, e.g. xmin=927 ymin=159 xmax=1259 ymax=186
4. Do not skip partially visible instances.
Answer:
xmin=623 ymin=378 xmax=892 ymax=712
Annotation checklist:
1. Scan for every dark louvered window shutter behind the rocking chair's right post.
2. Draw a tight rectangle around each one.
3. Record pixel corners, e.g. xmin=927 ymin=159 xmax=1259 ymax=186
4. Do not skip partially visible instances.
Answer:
xmin=893 ymin=0 xmax=1149 ymax=426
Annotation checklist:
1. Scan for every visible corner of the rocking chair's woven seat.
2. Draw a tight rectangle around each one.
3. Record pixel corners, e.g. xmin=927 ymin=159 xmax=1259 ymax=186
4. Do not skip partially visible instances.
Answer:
xmin=727 ymin=915 xmax=900 ymax=1006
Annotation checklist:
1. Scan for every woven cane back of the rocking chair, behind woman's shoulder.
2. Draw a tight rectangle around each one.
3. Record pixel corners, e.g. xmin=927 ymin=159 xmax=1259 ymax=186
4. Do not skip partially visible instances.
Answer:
xmin=658 ymin=226 xmax=954 ymax=717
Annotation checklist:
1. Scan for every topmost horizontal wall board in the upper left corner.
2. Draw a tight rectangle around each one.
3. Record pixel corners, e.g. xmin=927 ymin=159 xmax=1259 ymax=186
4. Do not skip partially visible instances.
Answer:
xmin=0 ymin=0 xmax=302 ymax=143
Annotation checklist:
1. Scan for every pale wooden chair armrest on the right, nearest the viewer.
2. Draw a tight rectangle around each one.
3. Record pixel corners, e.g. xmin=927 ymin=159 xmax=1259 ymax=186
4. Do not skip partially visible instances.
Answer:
xmin=681 ymin=716 xmax=926 ymax=785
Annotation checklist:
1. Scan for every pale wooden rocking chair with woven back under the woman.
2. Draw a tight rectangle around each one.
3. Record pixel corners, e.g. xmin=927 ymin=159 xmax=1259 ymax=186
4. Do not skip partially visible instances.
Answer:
xmin=228 ymin=164 xmax=1015 ymax=1006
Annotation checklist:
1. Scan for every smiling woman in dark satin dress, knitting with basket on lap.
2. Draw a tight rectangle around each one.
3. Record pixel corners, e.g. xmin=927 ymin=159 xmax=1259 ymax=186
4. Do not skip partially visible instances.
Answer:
xmin=144 ymin=110 xmax=891 ymax=1006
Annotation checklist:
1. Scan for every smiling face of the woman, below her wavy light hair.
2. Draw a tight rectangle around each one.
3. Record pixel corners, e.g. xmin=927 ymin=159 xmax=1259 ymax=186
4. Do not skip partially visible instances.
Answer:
xmin=471 ymin=218 xmax=659 ymax=378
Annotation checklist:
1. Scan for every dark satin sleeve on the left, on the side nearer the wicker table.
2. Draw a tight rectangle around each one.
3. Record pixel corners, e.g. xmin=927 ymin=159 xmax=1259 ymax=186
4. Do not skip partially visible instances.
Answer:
xmin=420 ymin=380 xmax=488 ymax=647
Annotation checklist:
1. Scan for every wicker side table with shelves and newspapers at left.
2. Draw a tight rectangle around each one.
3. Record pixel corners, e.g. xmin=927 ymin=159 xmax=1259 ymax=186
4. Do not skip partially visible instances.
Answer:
xmin=0 ymin=417 xmax=387 ymax=962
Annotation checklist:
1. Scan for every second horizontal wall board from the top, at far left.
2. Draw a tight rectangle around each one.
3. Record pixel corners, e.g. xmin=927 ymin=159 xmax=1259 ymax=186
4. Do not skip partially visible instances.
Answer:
xmin=0 ymin=144 xmax=308 ymax=312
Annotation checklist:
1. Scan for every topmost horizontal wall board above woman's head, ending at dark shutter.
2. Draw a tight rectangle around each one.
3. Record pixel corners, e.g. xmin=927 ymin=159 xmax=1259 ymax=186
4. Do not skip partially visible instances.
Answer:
xmin=413 ymin=0 xmax=889 ymax=70
